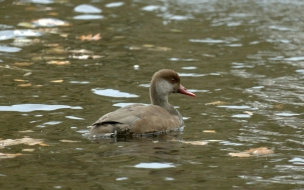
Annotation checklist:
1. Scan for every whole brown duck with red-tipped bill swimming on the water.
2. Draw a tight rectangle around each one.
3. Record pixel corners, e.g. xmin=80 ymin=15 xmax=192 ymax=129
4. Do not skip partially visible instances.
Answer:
xmin=89 ymin=69 xmax=196 ymax=137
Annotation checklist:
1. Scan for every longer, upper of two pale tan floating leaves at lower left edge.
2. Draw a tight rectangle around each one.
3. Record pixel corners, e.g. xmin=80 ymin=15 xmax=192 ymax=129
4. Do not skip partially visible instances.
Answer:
xmin=0 ymin=137 xmax=49 ymax=148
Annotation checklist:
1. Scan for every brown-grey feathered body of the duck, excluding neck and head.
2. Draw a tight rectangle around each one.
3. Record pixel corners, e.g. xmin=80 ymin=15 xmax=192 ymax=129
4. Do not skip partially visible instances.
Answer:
xmin=90 ymin=104 xmax=183 ymax=135
